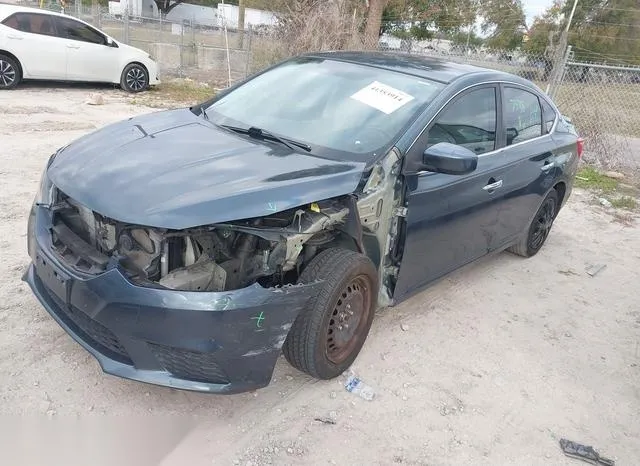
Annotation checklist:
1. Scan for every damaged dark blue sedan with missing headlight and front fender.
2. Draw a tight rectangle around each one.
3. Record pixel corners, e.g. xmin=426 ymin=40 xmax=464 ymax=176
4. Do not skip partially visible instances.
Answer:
xmin=24 ymin=52 xmax=582 ymax=393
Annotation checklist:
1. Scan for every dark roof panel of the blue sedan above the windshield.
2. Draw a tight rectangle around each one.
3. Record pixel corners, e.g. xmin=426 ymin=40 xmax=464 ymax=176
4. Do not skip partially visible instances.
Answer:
xmin=306 ymin=51 xmax=531 ymax=86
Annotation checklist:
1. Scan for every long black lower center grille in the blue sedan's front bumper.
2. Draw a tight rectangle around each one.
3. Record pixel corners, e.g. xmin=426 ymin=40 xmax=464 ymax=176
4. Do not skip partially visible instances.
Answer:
xmin=40 ymin=278 xmax=133 ymax=366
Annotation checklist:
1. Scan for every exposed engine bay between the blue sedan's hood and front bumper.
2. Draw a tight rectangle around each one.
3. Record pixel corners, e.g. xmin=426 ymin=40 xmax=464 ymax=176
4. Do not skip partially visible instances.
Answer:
xmin=54 ymin=195 xmax=356 ymax=291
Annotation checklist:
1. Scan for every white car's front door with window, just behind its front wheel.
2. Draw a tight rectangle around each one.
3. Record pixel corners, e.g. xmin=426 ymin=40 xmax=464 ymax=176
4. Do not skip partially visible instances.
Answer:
xmin=56 ymin=17 xmax=121 ymax=82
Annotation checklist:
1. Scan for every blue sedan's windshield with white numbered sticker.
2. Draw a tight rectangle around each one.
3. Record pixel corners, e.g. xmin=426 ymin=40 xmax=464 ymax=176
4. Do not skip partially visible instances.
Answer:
xmin=206 ymin=57 xmax=443 ymax=162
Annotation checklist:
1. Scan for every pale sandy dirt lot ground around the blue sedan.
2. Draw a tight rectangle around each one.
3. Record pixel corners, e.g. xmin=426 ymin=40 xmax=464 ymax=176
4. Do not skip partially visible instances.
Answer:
xmin=0 ymin=86 xmax=640 ymax=466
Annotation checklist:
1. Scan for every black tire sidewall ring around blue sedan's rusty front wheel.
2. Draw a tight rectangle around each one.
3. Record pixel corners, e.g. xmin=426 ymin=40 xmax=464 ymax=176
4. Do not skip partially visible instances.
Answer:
xmin=314 ymin=258 xmax=378 ymax=378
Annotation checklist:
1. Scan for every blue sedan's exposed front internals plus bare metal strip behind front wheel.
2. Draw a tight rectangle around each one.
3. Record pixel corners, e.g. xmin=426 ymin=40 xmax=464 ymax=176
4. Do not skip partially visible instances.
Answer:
xmin=52 ymin=147 xmax=406 ymax=305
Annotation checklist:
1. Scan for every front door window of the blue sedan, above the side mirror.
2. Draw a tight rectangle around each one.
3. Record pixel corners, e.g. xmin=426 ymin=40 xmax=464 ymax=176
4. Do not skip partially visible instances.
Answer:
xmin=427 ymin=88 xmax=497 ymax=154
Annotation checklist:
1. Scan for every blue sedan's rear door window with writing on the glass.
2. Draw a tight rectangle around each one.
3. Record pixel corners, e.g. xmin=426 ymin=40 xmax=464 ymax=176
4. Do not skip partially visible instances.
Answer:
xmin=504 ymin=87 xmax=542 ymax=146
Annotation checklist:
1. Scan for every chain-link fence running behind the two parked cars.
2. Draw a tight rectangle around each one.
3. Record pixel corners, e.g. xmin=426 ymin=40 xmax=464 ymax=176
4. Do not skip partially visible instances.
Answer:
xmin=22 ymin=2 xmax=640 ymax=170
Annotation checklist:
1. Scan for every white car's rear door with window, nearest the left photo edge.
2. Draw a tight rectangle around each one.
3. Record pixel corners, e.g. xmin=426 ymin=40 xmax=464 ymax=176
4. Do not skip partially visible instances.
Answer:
xmin=2 ymin=13 xmax=67 ymax=79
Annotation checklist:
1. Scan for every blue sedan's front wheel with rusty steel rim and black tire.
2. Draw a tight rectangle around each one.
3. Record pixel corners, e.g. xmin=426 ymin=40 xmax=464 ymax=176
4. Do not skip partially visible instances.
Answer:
xmin=282 ymin=248 xmax=378 ymax=379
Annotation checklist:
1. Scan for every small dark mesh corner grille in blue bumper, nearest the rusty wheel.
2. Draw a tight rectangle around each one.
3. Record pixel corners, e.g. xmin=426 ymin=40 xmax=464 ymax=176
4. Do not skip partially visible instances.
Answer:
xmin=148 ymin=343 xmax=229 ymax=384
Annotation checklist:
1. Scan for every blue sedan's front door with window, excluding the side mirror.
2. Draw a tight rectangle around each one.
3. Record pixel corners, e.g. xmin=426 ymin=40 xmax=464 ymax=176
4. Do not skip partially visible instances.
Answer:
xmin=394 ymin=85 xmax=506 ymax=299
